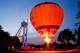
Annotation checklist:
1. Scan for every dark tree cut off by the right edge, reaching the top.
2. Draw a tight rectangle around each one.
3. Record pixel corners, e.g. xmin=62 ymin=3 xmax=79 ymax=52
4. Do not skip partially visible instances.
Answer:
xmin=74 ymin=0 xmax=80 ymax=45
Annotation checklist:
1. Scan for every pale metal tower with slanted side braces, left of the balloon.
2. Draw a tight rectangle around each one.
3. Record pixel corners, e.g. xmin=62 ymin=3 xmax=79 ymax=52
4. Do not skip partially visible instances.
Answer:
xmin=16 ymin=21 xmax=28 ymax=48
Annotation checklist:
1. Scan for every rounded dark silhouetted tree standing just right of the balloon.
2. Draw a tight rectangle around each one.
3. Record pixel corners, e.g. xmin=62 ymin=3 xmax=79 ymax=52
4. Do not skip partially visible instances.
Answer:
xmin=57 ymin=29 xmax=76 ymax=47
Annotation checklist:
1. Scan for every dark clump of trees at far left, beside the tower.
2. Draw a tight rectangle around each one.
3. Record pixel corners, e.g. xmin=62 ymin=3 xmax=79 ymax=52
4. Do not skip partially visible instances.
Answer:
xmin=0 ymin=25 xmax=21 ymax=50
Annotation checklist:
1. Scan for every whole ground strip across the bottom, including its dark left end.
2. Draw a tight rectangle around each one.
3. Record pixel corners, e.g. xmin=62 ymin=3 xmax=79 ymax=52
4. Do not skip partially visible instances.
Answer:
xmin=0 ymin=50 xmax=80 ymax=53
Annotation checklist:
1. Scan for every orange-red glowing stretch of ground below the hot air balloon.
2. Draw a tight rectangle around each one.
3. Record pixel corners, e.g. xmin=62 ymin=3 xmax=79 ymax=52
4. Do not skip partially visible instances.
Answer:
xmin=16 ymin=50 xmax=80 ymax=53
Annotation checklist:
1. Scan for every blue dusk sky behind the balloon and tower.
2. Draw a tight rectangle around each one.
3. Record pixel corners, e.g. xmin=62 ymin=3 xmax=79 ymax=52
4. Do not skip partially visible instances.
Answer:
xmin=0 ymin=0 xmax=78 ymax=44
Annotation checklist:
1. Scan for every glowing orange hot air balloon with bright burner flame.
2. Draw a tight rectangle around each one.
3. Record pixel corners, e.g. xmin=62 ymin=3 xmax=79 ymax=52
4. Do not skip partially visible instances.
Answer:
xmin=30 ymin=2 xmax=64 ymax=43
